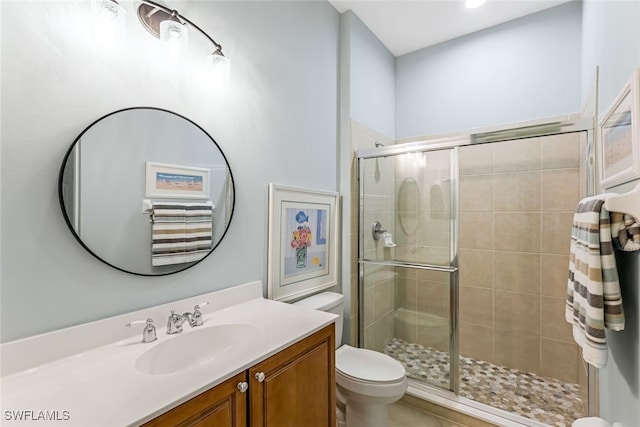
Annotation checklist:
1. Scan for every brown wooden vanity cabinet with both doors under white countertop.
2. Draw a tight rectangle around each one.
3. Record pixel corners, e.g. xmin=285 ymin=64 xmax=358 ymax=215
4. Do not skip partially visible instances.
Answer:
xmin=143 ymin=323 xmax=336 ymax=427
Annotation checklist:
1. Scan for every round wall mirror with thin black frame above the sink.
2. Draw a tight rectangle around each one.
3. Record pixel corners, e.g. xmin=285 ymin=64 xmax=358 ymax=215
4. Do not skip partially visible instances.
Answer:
xmin=58 ymin=107 xmax=235 ymax=276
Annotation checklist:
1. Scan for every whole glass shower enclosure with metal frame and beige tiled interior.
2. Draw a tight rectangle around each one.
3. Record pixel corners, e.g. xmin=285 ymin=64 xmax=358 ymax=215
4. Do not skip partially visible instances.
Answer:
xmin=357 ymin=125 xmax=592 ymax=425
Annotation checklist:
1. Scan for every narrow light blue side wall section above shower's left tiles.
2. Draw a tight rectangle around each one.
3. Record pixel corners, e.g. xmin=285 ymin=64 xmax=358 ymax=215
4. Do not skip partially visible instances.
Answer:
xmin=344 ymin=10 xmax=396 ymax=137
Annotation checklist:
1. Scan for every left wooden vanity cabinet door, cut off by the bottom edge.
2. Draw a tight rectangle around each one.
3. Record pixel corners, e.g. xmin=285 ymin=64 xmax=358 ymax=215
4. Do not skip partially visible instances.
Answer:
xmin=144 ymin=372 xmax=247 ymax=427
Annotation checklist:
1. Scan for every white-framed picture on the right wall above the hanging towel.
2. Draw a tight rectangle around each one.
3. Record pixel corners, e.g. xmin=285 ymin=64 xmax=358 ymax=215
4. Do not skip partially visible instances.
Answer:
xmin=598 ymin=70 xmax=640 ymax=189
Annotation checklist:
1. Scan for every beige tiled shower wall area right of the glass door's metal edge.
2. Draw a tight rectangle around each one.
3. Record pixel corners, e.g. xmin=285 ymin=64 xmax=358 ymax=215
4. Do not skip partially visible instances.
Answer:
xmin=459 ymin=133 xmax=584 ymax=383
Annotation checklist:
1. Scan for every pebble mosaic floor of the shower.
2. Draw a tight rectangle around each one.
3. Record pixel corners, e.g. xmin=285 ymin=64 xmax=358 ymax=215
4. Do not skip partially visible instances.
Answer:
xmin=385 ymin=338 xmax=583 ymax=427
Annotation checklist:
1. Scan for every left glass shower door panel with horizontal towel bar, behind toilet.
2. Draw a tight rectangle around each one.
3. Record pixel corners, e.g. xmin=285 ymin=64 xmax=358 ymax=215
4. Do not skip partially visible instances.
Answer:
xmin=358 ymin=147 xmax=458 ymax=391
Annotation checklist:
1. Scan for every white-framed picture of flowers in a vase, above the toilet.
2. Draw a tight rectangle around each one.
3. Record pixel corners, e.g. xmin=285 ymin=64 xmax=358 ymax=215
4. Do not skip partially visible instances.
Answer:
xmin=267 ymin=184 xmax=338 ymax=301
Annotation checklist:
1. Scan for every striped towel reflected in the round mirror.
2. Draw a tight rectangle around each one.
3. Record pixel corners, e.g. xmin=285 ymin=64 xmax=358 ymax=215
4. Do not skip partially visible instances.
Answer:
xmin=151 ymin=202 xmax=214 ymax=266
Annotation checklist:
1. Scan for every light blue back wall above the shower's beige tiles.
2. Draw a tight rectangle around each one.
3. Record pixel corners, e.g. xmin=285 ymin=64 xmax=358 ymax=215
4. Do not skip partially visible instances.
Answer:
xmin=396 ymin=2 xmax=581 ymax=139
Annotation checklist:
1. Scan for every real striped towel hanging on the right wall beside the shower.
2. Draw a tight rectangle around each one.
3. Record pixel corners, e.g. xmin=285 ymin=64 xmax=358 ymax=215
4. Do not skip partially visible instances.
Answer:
xmin=565 ymin=195 xmax=624 ymax=368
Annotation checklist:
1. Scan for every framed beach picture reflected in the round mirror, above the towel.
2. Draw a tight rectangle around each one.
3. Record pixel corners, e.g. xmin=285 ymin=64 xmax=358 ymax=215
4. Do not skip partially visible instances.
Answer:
xmin=145 ymin=162 xmax=210 ymax=199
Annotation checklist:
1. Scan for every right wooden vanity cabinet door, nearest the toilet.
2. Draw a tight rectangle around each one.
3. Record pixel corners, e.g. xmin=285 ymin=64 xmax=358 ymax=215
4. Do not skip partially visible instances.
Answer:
xmin=249 ymin=324 xmax=336 ymax=427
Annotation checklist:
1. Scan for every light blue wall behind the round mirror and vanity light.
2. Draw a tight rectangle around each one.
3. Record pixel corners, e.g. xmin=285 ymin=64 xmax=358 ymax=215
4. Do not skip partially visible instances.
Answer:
xmin=0 ymin=0 xmax=340 ymax=341
